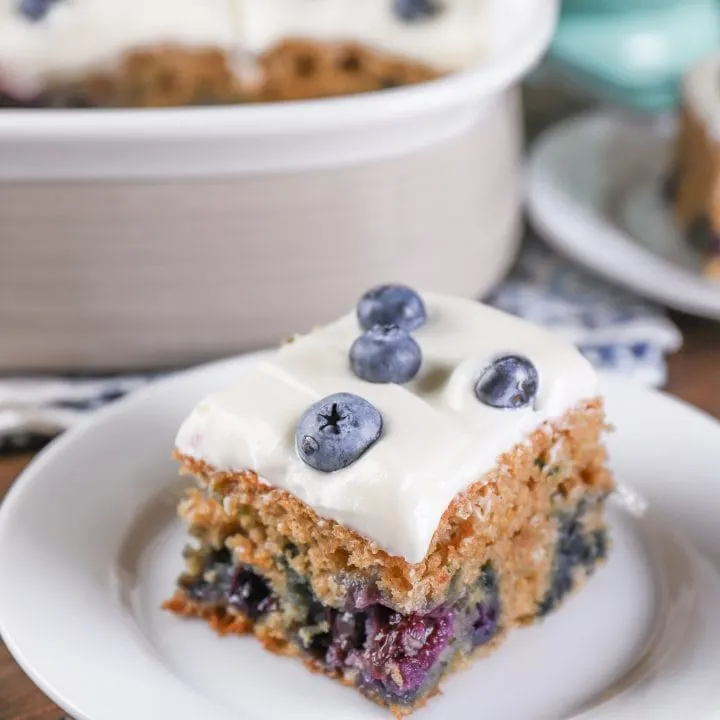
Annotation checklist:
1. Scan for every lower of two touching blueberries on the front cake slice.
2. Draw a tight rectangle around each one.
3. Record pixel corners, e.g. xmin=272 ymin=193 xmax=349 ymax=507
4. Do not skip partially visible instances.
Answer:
xmin=350 ymin=325 xmax=422 ymax=384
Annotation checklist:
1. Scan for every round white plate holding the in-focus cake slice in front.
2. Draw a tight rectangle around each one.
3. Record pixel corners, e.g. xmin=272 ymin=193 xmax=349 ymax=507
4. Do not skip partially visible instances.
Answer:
xmin=0 ymin=358 xmax=720 ymax=720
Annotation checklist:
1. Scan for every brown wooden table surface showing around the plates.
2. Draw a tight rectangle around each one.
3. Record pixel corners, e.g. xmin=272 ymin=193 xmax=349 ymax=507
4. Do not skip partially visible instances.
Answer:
xmin=0 ymin=315 xmax=720 ymax=720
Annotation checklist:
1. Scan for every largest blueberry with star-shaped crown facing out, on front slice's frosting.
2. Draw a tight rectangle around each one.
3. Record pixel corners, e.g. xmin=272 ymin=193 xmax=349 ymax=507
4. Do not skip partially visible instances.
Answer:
xmin=295 ymin=393 xmax=383 ymax=473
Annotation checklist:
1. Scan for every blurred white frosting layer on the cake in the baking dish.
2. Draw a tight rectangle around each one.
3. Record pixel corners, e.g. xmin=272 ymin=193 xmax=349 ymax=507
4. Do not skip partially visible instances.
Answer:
xmin=0 ymin=0 xmax=488 ymax=95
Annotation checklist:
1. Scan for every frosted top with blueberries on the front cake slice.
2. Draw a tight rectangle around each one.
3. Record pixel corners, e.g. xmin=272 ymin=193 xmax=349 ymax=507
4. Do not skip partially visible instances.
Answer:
xmin=176 ymin=291 xmax=597 ymax=563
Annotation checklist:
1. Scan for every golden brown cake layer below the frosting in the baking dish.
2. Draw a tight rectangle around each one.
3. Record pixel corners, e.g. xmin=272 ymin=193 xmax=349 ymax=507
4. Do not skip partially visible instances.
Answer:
xmin=0 ymin=40 xmax=440 ymax=108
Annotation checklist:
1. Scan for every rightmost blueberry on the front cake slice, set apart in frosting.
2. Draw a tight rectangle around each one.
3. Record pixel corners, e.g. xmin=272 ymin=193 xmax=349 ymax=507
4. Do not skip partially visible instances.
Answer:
xmin=475 ymin=355 xmax=540 ymax=410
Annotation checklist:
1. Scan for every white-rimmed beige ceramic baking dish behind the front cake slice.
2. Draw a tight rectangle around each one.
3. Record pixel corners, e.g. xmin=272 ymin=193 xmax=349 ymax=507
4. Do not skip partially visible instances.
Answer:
xmin=0 ymin=0 xmax=558 ymax=370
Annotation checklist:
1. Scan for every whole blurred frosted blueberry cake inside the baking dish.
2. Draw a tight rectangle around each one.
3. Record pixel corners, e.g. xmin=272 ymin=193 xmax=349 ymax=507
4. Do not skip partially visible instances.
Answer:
xmin=0 ymin=0 xmax=484 ymax=107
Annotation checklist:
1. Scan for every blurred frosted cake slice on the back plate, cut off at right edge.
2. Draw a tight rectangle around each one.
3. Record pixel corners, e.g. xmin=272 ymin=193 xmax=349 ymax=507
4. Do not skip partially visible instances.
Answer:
xmin=667 ymin=54 xmax=720 ymax=280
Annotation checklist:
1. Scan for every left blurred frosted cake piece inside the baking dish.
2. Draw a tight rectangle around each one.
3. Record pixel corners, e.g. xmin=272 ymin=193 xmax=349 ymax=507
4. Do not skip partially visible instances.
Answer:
xmin=0 ymin=0 xmax=238 ymax=107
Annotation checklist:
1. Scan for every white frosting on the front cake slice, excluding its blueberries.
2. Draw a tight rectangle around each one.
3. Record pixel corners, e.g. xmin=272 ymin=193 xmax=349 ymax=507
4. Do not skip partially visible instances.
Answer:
xmin=177 ymin=295 xmax=597 ymax=563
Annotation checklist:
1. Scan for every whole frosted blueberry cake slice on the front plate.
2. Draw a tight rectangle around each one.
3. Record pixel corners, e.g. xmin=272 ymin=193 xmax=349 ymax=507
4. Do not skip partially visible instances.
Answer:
xmin=166 ymin=285 xmax=612 ymax=717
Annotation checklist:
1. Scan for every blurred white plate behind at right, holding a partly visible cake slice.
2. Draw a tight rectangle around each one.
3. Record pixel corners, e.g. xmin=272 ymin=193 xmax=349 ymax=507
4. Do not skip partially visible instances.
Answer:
xmin=527 ymin=114 xmax=720 ymax=319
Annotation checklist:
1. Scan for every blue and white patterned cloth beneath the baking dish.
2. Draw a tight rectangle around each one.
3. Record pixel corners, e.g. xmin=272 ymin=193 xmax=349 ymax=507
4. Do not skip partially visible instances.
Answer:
xmin=0 ymin=238 xmax=682 ymax=453
